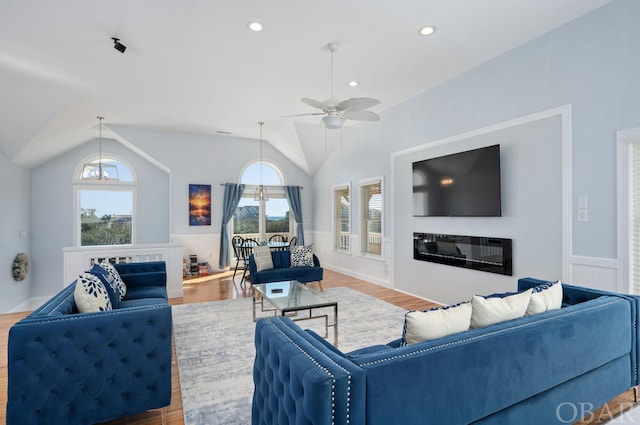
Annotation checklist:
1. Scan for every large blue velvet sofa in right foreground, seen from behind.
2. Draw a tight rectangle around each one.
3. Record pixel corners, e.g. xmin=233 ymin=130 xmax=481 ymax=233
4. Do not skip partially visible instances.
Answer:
xmin=252 ymin=278 xmax=639 ymax=425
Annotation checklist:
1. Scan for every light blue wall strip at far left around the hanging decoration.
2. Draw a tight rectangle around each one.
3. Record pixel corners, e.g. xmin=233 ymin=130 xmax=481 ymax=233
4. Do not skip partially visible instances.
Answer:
xmin=0 ymin=152 xmax=33 ymax=313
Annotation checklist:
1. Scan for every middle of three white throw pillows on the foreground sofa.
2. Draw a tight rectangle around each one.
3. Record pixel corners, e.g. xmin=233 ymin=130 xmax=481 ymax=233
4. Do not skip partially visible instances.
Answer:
xmin=471 ymin=289 xmax=531 ymax=328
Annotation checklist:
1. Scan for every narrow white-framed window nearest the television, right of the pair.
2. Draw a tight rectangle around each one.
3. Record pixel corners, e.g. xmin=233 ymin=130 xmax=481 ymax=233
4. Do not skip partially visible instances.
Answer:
xmin=360 ymin=178 xmax=383 ymax=256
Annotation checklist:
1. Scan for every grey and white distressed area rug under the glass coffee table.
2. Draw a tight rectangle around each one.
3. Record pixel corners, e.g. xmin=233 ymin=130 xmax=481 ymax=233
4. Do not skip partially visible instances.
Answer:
xmin=173 ymin=288 xmax=406 ymax=425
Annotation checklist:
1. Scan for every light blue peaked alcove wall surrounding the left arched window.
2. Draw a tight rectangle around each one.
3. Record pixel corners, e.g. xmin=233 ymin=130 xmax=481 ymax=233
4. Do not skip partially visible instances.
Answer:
xmin=31 ymin=139 xmax=169 ymax=297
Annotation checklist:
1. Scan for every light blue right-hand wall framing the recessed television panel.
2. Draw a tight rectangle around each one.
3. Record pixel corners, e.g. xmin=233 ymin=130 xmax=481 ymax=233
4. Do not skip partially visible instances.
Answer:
xmin=314 ymin=0 xmax=640 ymax=298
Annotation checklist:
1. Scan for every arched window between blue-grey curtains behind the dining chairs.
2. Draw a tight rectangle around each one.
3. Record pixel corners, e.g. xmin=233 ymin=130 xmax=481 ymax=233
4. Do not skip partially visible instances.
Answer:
xmin=232 ymin=161 xmax=293 ymax=241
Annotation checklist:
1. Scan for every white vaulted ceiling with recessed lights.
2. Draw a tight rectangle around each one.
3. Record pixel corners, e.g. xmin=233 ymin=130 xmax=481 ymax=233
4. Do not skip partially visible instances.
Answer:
xmin=0 ymin=0 xmax=610 ymax=174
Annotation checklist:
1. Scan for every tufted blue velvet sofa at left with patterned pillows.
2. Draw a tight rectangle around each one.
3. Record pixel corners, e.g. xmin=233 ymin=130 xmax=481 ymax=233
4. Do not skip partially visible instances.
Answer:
xmin=7 ymin=262 xmax=173 ymax=425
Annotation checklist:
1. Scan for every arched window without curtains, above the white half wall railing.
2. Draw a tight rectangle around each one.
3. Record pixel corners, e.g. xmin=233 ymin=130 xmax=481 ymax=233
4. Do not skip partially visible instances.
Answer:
xmin=73 ymin=154 xmax=137 ymax=246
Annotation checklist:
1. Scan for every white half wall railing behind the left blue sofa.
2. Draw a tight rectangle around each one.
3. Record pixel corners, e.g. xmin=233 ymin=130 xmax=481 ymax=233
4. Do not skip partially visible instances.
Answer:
xmin=62 ymin=243 xmax=184 ymax=298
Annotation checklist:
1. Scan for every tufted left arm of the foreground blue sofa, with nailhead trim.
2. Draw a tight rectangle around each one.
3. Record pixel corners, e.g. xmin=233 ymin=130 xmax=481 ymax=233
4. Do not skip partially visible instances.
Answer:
xmin=252 ymin=317 xmax=366 ymax=425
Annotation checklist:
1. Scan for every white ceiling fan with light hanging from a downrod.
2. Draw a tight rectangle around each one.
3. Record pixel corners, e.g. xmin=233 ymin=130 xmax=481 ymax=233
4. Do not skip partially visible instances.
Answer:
xmin=294 ymin=43 xmax=380 ymax=129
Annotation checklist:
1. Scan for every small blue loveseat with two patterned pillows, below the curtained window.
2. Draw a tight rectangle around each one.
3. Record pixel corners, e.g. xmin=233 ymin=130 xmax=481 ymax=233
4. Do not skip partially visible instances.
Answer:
xmin=249 ymin=251 xmax=323 ymax=290
